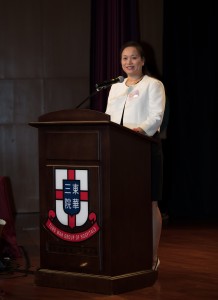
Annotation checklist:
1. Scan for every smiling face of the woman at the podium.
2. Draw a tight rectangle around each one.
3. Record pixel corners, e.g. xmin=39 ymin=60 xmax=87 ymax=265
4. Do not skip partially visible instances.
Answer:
xmin=121 ymin=47 xmax=144 ymax=76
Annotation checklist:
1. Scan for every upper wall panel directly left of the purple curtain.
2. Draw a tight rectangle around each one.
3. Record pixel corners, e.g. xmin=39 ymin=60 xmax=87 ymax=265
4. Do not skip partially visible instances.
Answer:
xmin=43 ymin=0 xmax=91 ymax=78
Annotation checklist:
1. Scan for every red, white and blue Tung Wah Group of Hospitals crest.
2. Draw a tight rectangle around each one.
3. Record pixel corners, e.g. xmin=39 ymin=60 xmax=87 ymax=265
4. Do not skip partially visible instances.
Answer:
xmin=45 ymin=169 xmax=99 ymax=242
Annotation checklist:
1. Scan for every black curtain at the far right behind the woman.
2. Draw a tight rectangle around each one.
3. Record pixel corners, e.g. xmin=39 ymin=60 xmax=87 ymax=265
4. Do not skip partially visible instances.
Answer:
xmin=163 ymin=0 xmax=218 ymax=218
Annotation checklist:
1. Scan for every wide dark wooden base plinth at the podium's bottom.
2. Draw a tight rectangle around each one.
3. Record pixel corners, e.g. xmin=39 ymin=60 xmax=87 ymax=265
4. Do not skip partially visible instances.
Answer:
xmin=35 ymin=269 xmax=158 ymax=295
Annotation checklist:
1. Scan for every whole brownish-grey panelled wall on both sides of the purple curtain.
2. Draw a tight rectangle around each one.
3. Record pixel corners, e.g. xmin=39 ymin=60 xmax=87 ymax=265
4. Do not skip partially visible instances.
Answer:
xmin=0 ymin=0 xmax=163 ymax=212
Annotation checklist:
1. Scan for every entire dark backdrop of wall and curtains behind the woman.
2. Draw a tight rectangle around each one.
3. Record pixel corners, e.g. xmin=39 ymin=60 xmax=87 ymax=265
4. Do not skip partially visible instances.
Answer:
xmin=0 ymin=0 xmax=218 ymax=218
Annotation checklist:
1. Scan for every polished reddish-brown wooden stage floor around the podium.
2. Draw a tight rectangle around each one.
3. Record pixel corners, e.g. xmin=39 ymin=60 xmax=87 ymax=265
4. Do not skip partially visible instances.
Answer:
xmin=0 ymin=214 xmax=218 ymax=300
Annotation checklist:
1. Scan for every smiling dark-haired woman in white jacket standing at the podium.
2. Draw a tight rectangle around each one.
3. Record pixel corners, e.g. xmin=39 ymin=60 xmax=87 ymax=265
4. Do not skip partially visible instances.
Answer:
xmin=106 ymin=41 xmax=165 ymax=270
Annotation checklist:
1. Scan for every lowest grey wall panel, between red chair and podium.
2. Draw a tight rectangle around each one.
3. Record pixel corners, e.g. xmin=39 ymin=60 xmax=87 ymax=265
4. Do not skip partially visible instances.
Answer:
xmin=0 ymin=125 xmax=39 ymax=212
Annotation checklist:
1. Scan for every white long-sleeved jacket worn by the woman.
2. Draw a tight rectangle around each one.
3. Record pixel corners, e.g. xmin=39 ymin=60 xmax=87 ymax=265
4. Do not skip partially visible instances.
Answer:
xmin=105 ymin=75 xmax=166 ymax=136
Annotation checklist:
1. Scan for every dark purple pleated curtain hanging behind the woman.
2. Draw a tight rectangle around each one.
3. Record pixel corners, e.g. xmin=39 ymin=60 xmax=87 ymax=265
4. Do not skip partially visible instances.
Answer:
xmin=90 ymin=0 xmax=140 ymax=112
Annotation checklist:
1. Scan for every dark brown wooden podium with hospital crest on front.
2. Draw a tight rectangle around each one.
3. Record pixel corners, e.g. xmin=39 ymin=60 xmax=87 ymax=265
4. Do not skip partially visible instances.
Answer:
xmin=29 ymin=109 xmax=157 ymax=294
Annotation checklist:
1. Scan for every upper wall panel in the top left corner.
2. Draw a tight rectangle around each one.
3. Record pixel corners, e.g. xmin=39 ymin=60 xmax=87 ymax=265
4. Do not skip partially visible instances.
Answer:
xmin=0 ymin=0 xmax=42 ymax=79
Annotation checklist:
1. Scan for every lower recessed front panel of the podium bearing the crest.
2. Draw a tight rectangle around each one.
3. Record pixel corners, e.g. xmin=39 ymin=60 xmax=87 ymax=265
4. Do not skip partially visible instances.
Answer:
xmin=40 ymin=164 xmax=102 ymax=273
